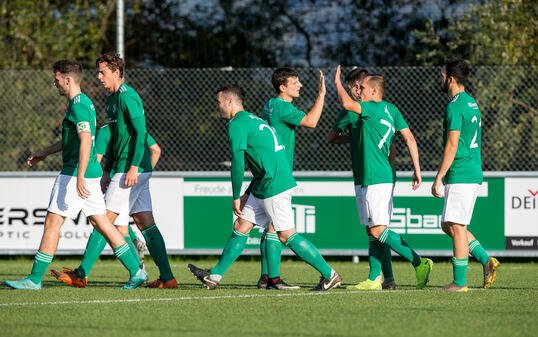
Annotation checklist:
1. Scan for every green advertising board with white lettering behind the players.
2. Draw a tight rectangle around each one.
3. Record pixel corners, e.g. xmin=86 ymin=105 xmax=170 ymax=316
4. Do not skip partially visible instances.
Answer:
xmin=184 ymin=177 xmax=505 ymax=255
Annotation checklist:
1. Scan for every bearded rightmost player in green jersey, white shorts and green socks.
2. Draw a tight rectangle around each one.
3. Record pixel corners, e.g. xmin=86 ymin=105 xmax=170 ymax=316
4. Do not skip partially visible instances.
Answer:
xmin=432 ymin=59 xmax=500 ymax=292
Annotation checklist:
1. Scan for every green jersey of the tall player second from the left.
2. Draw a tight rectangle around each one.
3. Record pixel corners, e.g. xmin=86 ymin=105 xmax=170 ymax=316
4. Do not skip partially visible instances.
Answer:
xmin=105 ymin=84 xmax=153 ymax=173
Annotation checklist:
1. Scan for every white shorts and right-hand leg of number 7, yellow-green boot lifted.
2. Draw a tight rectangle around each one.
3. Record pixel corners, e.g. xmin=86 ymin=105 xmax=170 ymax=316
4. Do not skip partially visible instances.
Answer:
xmin=363 ymin=184 xmax=433 ymax=289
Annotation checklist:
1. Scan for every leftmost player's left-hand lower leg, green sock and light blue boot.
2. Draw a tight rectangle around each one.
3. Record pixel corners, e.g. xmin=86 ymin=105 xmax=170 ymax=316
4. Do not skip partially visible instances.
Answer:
xmin=5 ymin=212 xmax=65 ymax=290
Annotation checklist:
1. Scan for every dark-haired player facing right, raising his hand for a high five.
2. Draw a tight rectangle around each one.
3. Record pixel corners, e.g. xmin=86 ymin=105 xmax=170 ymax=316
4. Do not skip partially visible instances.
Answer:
xmin=246 ymin=68 xmax=326 ymax=290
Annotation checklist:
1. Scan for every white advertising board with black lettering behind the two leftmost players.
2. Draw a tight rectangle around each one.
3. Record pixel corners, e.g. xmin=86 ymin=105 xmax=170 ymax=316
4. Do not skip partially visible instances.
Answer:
xmin=0 ymin=177 xmax=184 ymax=254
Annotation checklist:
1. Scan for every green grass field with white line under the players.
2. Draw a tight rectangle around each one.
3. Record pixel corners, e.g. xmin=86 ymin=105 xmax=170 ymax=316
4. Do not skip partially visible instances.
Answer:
xmin=0 ymin=258 xmax=538 ymax=337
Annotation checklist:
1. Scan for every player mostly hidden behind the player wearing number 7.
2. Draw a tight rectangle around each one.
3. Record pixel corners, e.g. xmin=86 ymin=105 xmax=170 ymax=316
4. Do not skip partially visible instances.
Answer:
xmin=327 ymin=68 xmax=396 ymax=290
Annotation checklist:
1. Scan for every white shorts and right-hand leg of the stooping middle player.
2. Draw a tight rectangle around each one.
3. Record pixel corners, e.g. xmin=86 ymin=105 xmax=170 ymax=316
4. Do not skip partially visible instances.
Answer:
xmin=268 ymin=190 xmax=342 ymax=291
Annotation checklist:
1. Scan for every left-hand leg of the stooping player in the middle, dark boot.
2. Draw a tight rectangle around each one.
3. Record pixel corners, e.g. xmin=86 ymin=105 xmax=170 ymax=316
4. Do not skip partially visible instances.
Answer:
xmin=188 ymin=218 xmax=254 ymax=290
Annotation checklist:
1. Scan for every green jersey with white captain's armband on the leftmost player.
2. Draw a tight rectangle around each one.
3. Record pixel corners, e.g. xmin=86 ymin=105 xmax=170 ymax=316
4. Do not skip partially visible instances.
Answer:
xmin=61 ymin=93 xmax=103 ymax=178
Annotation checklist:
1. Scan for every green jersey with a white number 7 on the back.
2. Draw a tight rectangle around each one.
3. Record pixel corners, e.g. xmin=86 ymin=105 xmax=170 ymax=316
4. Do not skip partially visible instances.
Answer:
xmin=359 ymin=101 xmax=409 ymax=186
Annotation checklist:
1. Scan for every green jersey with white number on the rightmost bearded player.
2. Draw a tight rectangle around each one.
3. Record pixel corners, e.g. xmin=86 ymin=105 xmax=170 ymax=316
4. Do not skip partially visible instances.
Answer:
xmin=443 ymin=92 xmax=483 ymax=184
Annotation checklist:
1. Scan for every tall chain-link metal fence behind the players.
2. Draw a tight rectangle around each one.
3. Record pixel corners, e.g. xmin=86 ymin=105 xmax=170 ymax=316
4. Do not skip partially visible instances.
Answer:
xmin=0 ymin=66 xmax=538 ymax=171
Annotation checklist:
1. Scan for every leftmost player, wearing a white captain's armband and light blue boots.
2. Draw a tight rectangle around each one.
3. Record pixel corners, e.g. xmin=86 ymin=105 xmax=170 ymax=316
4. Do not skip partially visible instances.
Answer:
xmin=5 ymin=60 xmax=147 ymax=290
